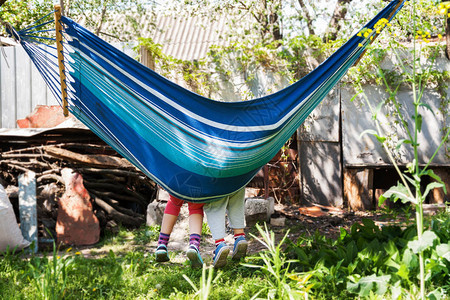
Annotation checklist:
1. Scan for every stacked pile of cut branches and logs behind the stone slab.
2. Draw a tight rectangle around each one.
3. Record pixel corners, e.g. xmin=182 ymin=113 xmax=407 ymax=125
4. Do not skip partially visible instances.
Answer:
xmin=0 ymin=130 xmax=157 ymax=238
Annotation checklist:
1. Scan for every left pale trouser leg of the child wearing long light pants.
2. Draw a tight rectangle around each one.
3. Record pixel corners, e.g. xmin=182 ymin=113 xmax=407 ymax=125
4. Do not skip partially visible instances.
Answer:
xmin=203 ymin=196 xmax=229 ymax=240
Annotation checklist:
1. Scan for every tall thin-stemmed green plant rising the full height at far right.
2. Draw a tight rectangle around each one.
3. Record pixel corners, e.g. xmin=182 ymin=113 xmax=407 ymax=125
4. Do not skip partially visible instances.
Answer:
xmin=359 ymin=1 xmax=450 ymax=299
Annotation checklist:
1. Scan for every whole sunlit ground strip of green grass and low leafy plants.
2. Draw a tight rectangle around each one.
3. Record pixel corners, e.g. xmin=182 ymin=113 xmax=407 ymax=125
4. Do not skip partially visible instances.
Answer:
xmin=0 ymin=212 xmax=450 ymax=299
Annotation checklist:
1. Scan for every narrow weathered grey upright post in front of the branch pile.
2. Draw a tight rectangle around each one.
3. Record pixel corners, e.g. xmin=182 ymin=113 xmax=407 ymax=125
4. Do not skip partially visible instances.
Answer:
xmin=19 ymin=171 xmax=38 ymax=252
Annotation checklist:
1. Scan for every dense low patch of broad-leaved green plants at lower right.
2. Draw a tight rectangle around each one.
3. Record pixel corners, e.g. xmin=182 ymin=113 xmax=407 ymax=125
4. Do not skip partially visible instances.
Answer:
xmin=287 ymin=213 xmax=450 ymax=299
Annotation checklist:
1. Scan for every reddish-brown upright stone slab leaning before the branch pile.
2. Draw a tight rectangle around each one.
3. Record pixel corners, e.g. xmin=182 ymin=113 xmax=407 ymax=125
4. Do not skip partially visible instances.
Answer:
xmin=56 ymin=168 xmax=100 ymax=246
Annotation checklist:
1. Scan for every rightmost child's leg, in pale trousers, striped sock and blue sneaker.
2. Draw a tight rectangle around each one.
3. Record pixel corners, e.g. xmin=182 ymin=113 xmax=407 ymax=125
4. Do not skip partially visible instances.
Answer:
xmin=228 ymin=189 xmax=248 ymax=259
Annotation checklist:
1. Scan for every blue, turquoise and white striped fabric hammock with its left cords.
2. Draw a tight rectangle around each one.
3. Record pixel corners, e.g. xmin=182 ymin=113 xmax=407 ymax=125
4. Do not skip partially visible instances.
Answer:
xmin=9 ymin=0 xmax=406 ymax=202
